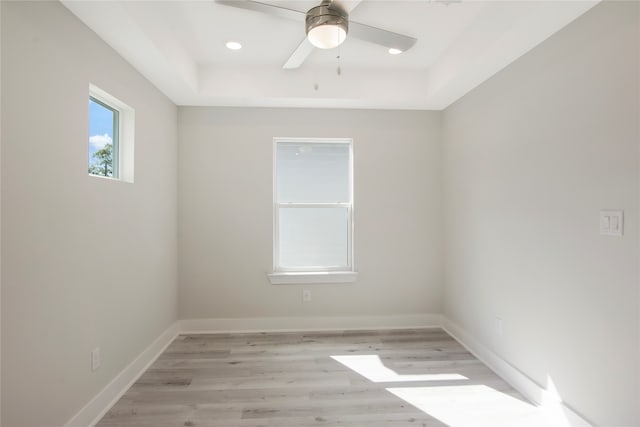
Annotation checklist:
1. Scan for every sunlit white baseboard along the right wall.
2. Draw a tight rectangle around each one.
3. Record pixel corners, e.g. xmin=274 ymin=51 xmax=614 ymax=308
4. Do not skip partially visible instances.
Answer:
xmin=441 ymin=316 xmax=593 ymax=427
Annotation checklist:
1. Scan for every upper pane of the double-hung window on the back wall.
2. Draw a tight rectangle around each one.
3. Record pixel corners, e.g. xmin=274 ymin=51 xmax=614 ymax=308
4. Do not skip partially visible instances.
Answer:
xmin=276 ymin=142 xmax=351 ymax=203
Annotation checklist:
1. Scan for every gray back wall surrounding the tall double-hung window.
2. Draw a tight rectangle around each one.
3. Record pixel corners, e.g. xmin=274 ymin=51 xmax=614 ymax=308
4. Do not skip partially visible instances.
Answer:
xmin=178 ymin=108 xmax=441 ymax=322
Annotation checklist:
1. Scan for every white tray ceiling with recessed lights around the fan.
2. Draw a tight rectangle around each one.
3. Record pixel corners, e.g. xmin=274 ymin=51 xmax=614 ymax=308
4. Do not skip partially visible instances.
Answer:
xmin=61 ymin=0 xmax=599 ymax=110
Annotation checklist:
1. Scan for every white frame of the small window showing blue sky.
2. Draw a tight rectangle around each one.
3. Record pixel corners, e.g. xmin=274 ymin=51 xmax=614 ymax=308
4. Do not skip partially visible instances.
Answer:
xmin=89 ymin=84 xmax=135 ymax=183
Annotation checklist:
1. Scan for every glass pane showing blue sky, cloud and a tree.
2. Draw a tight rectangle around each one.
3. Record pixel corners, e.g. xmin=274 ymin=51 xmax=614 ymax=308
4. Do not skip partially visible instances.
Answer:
xmin=89 ymin=98 xmax=118 ymax=178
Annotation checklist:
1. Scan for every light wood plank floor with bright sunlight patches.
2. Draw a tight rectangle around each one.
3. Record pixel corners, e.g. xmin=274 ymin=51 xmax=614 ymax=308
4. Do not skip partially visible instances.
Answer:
xmin=98 ymin=329 xmax=539 ymax=427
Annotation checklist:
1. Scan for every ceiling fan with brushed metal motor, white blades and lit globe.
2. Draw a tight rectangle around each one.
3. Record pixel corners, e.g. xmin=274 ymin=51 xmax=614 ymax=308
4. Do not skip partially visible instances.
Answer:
xmin=215 ymin=0 xmax=417 ymax=69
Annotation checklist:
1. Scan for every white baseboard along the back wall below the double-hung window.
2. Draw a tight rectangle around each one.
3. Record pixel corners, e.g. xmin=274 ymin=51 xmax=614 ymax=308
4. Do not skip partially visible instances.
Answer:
xmin=180 ymin=314 xmax=440 ymax=333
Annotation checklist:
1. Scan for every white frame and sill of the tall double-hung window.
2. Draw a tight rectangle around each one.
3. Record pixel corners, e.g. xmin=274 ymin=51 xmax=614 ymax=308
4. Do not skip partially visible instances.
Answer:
xmin=269 ymin=137 xmax=357 ymax=284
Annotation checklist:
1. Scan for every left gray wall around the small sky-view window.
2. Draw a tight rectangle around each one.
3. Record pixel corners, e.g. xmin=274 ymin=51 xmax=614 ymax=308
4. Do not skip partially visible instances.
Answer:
xmin=1 ymin=2 xmax=177 ymax=427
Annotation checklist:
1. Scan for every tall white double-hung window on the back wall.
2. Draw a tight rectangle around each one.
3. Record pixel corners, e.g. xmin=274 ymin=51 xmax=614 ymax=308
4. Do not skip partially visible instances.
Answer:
xmin=270 ymin=138 xmax=355 ymax=283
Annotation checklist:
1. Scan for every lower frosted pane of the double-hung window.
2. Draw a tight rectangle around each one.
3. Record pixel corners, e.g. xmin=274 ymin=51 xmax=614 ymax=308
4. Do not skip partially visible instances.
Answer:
xmin=279 ymin=207 xmax=349 ymax=268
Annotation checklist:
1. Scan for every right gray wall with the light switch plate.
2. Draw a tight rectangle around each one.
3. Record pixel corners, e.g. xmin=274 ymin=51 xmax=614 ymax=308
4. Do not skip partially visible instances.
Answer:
xmin=443 ymin=2 xmax=640 ymax=427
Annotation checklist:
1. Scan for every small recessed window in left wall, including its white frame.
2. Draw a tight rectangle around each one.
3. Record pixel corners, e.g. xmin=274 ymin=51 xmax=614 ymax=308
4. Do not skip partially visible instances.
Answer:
xmin=88 ymin=85 xmax=135 ymax=182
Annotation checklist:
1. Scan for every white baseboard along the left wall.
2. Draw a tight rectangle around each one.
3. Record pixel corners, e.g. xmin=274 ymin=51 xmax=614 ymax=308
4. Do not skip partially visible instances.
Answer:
xmin=65 ymin=322 xmax=180 ymax=427
